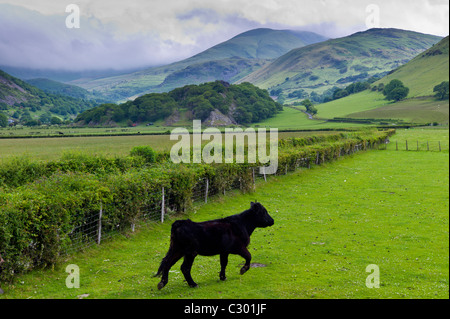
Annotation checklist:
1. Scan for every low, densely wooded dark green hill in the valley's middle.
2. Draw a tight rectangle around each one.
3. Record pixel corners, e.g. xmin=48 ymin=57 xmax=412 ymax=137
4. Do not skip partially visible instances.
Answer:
xmin=75 ymin=81 xmax=283 ymax=126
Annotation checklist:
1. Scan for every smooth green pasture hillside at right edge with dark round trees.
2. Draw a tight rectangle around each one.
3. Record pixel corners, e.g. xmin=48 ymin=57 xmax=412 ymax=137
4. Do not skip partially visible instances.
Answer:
xmin=316 ymin=36 xmax=449 ymax=123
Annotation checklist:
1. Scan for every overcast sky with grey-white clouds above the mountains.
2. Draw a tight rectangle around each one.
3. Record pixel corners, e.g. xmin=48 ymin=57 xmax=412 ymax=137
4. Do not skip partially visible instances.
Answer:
xmin=0 ymin=0 xmax=449 ymax=70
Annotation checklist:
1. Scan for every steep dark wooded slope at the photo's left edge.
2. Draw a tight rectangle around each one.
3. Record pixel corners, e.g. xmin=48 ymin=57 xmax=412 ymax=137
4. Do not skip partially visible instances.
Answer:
xmin=0 ymin=70 xmax=99 ymax=125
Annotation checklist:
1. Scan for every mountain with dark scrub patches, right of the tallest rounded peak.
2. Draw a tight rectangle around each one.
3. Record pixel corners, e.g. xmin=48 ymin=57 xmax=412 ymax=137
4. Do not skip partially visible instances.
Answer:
xmin=239 ymin=28 xmax=441 ymax=102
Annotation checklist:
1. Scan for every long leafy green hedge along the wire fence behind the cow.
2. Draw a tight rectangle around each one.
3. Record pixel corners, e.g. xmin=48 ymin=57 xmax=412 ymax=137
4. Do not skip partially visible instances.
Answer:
xmin=0 ymin=131 xmax=393 ymax=280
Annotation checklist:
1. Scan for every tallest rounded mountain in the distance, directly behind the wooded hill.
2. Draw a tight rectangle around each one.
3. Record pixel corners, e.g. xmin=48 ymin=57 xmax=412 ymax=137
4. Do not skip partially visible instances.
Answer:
xmin=72 ymin=28 xmax=326 ymax=100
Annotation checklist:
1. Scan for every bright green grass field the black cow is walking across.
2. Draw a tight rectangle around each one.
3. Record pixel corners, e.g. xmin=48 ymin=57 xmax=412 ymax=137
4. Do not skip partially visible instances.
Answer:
xmin=1 ymin=130 xmax=449 ymax=299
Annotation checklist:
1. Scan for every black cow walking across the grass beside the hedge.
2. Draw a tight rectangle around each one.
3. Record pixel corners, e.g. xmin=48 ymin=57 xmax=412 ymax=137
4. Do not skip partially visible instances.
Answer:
xmin=155 ymin=202 xmax=274 ymax=289
